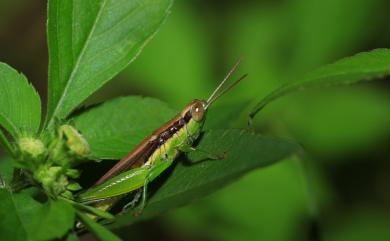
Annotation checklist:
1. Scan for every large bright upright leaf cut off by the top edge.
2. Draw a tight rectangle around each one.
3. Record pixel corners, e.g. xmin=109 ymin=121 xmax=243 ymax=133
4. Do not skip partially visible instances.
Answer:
xmin=47 ymin=0 xmax=172 ymax=125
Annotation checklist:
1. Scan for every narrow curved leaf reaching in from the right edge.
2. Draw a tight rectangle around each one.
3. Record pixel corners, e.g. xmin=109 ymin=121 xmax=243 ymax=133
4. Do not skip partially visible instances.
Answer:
xmin=250 ymin=49 xmax=390 ymax=119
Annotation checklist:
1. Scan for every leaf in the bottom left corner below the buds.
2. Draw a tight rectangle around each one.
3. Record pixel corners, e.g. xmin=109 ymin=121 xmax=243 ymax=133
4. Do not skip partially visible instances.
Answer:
xmin=0 ymin=189 xmax=74 ymax=241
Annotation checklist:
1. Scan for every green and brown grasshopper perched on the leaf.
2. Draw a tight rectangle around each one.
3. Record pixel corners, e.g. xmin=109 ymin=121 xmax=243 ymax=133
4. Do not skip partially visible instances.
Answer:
xmin=77 ymin=60 xmax=247 ymax=216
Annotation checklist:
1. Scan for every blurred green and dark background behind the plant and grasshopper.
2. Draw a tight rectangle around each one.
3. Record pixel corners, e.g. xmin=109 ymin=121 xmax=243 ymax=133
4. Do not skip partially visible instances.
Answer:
xmin=0 ymin=0 xmax=390 ymax=241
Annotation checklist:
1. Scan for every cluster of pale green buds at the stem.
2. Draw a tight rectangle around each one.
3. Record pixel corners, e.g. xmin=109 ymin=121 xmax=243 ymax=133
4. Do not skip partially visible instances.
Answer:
xmin=17 ymin=124 xmax=90 ymax=198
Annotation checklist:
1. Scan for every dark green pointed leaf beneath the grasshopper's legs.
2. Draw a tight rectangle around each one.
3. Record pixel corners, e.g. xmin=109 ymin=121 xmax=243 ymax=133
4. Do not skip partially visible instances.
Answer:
xmin=109 ymin=129 xmax=300 ymax=227
